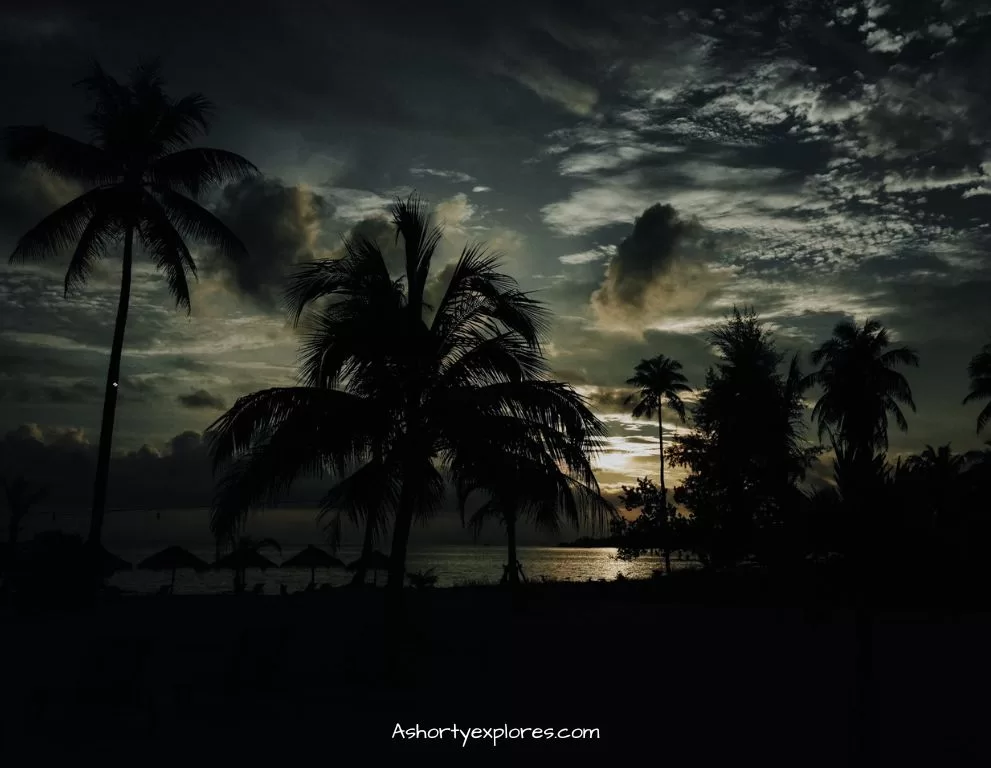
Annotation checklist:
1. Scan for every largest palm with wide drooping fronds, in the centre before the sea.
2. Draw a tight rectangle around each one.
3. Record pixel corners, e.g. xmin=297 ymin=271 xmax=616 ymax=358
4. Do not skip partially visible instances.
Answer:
xmin=209 ymin=190 xmax=605 ymax=597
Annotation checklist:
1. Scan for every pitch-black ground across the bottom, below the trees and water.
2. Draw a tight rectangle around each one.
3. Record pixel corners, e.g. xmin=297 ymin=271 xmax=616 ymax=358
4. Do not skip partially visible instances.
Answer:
xmin=0 ymin=584 xmax=991 ymax=766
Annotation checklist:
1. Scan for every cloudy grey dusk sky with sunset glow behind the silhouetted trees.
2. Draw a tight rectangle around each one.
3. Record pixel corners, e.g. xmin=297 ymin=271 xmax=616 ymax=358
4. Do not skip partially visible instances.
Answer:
xmin=0 ymin=0 xmax=991 ymax=540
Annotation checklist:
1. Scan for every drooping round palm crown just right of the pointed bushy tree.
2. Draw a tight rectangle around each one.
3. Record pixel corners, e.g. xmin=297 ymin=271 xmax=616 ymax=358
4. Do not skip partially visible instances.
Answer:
xmin=806 ymin=320 xmax=919 ymax=461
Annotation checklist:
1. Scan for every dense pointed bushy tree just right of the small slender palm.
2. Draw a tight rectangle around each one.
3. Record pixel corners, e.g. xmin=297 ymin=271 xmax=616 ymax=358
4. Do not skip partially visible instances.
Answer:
xmin=669 ymin=309 xmax=820 ymax=565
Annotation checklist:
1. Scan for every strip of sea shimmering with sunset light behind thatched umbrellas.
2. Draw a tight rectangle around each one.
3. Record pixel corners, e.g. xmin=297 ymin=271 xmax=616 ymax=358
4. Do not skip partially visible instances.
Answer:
xmin=110 ymin=546 xmax=691 ymax=594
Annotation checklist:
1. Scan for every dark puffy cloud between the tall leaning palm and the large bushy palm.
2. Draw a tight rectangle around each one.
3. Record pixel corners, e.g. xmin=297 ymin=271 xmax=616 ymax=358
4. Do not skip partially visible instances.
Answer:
xmin=204 ymin=178 xmax=334 ymax=310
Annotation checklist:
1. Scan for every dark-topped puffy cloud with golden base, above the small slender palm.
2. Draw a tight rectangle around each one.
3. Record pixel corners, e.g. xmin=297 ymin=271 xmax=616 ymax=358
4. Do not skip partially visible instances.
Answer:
xmin=591 ymin=204 xmax=725 ymax=329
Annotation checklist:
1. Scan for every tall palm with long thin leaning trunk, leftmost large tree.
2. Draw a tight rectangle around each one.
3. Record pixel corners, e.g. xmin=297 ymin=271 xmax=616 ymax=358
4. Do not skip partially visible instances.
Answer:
xmin=3 ymin=65 xmax=257 ymax=546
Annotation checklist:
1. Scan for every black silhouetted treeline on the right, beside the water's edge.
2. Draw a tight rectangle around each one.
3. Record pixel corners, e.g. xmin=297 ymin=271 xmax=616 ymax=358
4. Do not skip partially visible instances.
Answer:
xmin=612 ymin=309 xmax=991 ymax=600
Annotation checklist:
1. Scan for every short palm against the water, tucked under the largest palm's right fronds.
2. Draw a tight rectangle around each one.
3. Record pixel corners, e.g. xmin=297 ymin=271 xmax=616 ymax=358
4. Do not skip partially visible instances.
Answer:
xmin=452 ymin=420 xmax=613 ymax=586
